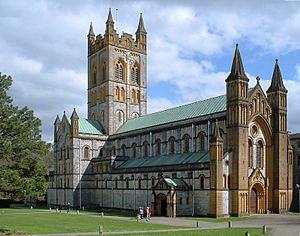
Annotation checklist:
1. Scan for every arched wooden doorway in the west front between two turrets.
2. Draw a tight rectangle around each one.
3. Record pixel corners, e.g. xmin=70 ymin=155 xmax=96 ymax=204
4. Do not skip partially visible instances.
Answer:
xmin=249 ymin=184 xmax=265 ymax=214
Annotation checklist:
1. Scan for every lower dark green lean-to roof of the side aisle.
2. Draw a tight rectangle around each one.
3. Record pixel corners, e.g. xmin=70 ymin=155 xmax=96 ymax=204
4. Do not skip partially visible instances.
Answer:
xmin=118 ymin=152 xmax=210 ymax=169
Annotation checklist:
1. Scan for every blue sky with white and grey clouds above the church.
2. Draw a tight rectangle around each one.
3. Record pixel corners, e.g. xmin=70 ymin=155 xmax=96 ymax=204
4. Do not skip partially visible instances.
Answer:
xmin=0 ymin=0 xmax=300 ymax=141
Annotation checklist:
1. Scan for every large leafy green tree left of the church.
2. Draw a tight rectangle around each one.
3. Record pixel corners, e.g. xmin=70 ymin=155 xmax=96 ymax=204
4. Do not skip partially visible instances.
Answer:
xmin=0 ymin=73 xmax=49 ymax=200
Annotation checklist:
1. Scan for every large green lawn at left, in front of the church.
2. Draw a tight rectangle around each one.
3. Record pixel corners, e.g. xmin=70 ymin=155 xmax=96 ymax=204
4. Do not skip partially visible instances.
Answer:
xmin=0 ymin=210 xmax=176 ymax=234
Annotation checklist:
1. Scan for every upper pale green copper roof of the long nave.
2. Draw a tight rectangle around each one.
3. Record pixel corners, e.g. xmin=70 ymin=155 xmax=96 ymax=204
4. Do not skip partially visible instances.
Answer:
xmin=117 ymin=95 xmax=226 ymax=133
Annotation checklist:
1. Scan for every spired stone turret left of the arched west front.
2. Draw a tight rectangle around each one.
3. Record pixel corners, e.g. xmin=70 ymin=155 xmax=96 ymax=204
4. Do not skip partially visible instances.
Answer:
xmin=226 ymin=45 xmax=249 ymax=216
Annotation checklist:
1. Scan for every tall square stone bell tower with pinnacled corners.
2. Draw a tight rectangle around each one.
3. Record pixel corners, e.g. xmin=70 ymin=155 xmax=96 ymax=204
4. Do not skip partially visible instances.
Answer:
xmin=87 ymin=9 xmax=147 ymax=135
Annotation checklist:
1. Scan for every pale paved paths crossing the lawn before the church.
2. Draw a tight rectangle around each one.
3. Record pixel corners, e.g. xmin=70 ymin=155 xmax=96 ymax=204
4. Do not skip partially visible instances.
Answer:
xmin=37 ymin=214 xmax=300 ymax=236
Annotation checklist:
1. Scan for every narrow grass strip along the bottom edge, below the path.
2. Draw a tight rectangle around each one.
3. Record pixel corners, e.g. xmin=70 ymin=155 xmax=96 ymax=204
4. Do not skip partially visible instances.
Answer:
xmin=114 ymin=228 xmax=270 ymax=236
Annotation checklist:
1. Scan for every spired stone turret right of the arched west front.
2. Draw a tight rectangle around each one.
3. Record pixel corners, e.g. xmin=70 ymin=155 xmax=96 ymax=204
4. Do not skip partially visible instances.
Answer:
xmin=267 ymin=59 xmax=292 ymax=213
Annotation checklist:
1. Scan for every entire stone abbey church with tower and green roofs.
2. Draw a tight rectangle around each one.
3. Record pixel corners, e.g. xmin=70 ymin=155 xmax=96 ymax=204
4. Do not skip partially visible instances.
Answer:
xmin=47 ymin=10 xmax=293 ymax=217
